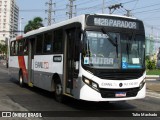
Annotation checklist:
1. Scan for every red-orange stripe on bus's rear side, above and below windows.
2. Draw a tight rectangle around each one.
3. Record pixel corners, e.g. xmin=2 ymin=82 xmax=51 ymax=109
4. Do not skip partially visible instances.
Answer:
xmin=16 ymin=36 xmax=28 ymax=80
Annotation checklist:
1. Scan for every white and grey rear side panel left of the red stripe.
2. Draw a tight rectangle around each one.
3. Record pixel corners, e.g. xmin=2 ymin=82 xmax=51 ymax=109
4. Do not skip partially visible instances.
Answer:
xmin=9 ymin=56 xmax=19 ymax=80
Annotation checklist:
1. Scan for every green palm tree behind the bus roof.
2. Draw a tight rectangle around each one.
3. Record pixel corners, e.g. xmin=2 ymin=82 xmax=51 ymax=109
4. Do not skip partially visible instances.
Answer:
xmin=24 ymin=17 xmax=44 ymax=33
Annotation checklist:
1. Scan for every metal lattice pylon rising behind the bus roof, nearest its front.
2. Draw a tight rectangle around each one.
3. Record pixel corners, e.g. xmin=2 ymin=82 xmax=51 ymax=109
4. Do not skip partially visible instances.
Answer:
xmin=66 ymin=0 xmax=76 ymax=19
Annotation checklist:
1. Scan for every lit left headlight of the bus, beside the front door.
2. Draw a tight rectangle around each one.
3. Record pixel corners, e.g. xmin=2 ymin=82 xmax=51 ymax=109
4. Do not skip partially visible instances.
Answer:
xmin=82 ymin=76 xmax=99 ymax=92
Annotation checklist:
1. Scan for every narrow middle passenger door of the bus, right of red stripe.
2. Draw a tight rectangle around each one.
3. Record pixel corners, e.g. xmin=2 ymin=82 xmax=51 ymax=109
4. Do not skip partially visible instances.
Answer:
xmin=28 ymin=38 xmax=35 ymax=87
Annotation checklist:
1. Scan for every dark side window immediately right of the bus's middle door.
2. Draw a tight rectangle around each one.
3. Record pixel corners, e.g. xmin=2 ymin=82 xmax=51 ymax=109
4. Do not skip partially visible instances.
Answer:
xmin=36 ymin=34 xmax=43 ymax=54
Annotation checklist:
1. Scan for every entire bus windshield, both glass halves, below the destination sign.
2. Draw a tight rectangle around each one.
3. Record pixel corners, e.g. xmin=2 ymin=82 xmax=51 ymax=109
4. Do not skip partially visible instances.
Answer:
xmin=82 ymin=31 xmax=145 ymax=69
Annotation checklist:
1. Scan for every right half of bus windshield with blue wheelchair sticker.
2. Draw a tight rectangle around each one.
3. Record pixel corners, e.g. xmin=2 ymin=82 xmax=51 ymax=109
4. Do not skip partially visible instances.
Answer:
xmin=121 ymin=34 xmax=145 ymax=69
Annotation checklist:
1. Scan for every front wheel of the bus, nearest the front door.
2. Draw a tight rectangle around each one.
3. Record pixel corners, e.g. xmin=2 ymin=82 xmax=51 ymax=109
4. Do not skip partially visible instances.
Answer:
xmin=55 ymin=82 xmax=64 ymax=103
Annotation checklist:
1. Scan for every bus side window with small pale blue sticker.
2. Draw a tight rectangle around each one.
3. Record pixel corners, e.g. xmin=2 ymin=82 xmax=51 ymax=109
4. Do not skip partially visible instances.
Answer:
xmin=43 ymin=32 xmax=52 ymax=53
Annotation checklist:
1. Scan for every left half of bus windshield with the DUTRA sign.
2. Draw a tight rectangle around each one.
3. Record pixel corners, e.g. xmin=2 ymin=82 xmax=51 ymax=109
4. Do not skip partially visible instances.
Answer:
xmin=83 ymin=31 xmax=120 ymax=68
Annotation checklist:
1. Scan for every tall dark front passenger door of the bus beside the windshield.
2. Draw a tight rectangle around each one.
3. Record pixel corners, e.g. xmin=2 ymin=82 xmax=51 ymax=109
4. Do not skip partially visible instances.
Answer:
xmin=64 ymin=28 xmax=79 ymax=94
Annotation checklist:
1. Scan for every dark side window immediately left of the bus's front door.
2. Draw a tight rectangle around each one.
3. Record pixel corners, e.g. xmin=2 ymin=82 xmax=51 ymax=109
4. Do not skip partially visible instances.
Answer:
xmin=53 ymin=29 xmax=63 ymax=53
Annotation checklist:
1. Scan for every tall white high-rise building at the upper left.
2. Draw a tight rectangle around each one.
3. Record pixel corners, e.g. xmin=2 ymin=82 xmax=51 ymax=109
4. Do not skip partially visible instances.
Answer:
xmin=0 ymin=0 xmax=19 ymax=41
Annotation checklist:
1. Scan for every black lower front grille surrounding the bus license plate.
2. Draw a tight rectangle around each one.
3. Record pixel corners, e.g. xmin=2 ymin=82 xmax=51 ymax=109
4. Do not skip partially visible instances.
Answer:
xmin=100 ymin=87 xmax=139 ymax=98
